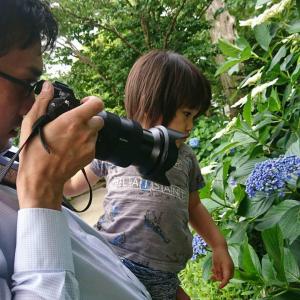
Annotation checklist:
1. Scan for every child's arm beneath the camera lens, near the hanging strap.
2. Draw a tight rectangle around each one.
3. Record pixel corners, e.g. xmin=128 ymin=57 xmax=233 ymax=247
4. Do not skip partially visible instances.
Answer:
xmin=64 ymin=165 xmax=99 ymax=196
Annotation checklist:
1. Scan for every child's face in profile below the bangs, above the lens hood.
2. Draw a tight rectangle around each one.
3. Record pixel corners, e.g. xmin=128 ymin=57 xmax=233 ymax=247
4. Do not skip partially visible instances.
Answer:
xmin=168 ymin=107 xmax=199 ymax=143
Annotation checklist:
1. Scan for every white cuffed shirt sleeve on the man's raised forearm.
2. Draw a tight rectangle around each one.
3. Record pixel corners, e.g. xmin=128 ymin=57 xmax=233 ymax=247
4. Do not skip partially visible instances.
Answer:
xmin=11 ymin=208 xmax=80 ymax=300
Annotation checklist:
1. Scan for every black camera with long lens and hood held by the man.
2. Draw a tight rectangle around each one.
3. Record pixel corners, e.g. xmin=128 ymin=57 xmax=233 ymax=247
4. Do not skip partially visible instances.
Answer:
xmin=35 ymin=81 xmax=186 ymax=185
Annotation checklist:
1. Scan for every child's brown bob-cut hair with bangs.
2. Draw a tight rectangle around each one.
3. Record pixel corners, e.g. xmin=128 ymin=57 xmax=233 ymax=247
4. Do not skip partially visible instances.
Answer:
xmin=125 ymin=50 xmax=211 ymax=128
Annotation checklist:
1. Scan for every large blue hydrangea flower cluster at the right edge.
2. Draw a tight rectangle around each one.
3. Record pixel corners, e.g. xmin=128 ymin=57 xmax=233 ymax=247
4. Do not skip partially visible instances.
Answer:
xmin=246 ymin=155 xmax=300 ymax=198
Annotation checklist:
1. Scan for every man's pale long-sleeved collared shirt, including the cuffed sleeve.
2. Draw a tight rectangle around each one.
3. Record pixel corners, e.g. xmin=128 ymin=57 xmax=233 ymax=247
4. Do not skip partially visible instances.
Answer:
xmin=0 ymin=185 xmax=151 ymax=300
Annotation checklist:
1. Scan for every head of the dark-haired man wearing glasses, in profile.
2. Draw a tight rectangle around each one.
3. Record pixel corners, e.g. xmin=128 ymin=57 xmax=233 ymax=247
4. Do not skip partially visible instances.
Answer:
xmin=0 ymin=0 xmax=58 ymax=151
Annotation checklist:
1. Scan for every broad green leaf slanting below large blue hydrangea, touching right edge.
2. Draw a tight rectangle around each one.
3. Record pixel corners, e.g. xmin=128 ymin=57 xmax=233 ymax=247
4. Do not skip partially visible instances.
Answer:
xmin=255 ymin=200 xmax=299 ymax=231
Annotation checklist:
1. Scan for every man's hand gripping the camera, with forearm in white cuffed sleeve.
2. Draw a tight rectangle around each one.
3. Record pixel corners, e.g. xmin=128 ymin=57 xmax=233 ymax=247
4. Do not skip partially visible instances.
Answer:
xmin=10 ymin=84 xmax=103 ymax=300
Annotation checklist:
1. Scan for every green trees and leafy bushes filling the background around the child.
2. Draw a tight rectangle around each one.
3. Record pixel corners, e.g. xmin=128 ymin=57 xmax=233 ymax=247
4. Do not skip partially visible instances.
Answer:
xmin=47 ymin=0 xmax=300 ymax=299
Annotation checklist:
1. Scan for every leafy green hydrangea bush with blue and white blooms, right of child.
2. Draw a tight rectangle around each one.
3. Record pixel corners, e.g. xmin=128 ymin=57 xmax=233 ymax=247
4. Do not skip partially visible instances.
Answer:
xmin=182 ymin=0 xmax=300 ymax=299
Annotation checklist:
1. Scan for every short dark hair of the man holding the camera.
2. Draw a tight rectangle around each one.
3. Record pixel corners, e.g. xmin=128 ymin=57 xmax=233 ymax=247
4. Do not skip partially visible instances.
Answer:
xmin=0 ymin=0 xmax=58 ymax=56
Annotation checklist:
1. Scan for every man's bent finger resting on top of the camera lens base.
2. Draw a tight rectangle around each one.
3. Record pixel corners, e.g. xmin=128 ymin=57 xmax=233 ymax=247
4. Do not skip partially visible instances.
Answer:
xmin=68 ymin=96 xmax=104 ymax=121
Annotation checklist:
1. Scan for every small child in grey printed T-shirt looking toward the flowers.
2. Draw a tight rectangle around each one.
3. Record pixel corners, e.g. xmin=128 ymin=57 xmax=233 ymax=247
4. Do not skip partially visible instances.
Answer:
xmin=65 ymin=50 xmax=233 ymax=300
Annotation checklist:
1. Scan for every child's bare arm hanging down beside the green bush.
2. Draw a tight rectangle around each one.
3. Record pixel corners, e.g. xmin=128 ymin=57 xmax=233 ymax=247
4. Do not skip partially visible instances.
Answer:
xmin=189 ymin=191 xmax=233 ymax=288
